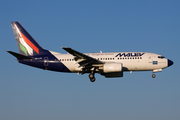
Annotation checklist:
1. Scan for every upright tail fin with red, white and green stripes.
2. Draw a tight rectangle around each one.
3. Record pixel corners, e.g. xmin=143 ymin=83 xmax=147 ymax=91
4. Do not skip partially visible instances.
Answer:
xmin=11 ymin=22 xmax=46 ymax=56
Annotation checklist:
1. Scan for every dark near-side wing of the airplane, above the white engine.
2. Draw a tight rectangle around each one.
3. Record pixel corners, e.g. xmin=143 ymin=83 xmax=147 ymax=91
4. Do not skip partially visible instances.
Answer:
xmin=62 ymin=47 xmax=104 ymax=67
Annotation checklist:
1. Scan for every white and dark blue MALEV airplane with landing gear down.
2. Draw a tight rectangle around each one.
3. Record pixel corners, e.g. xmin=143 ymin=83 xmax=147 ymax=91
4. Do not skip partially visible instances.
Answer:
xmin=7 ymin=22 xmax=173 ymax=82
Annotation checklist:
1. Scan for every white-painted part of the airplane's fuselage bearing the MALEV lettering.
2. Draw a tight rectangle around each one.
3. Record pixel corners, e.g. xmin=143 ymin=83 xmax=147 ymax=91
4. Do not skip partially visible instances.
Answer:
xmin=51 ymin=52 xmax=168 ymax=72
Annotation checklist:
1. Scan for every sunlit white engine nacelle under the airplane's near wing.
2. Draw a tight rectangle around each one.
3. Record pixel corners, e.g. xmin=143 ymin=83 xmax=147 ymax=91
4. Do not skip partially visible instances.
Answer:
xmin=103 ymin=63 xmax=122 ymax=73
